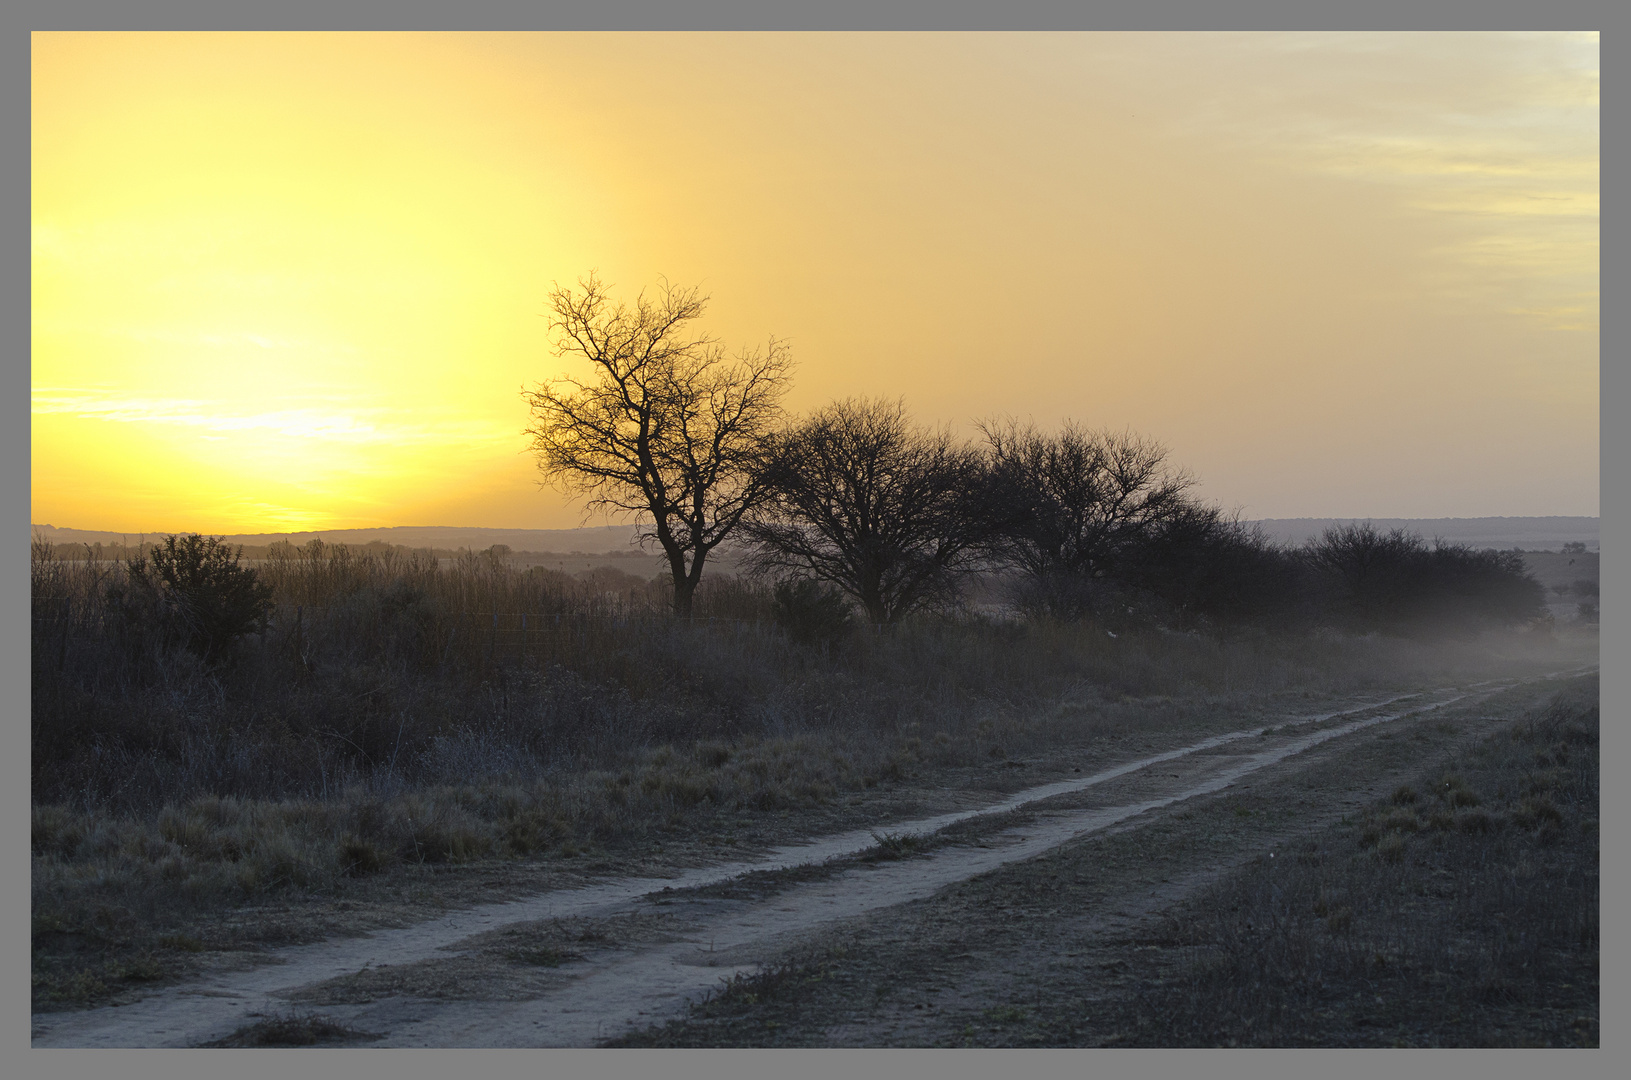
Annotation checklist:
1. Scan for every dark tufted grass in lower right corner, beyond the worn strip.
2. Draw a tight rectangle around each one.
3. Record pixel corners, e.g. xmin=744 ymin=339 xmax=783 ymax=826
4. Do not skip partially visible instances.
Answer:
xmin=1109 ymin=679 xmax=1600 ymax=1046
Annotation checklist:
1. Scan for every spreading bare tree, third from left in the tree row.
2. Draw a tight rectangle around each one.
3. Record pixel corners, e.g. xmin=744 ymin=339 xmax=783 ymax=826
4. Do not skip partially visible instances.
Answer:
xmin=980 ymin=419 xmax=1194 ymax=617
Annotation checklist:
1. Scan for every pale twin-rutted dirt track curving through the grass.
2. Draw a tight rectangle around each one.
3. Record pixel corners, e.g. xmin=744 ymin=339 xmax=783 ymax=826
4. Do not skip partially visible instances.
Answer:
xmin=33 ymin=672 xmax=1585 ymax=1046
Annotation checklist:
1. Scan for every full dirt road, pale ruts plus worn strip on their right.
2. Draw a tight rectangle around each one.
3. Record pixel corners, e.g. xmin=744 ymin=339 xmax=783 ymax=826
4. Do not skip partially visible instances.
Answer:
xmin=33 ymin=668 xmax=1591 ymax=1047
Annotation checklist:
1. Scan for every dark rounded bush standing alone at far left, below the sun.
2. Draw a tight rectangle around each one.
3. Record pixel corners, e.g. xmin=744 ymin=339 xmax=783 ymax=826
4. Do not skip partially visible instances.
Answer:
xmin=108 ymin=533 xmax=272 ymax=662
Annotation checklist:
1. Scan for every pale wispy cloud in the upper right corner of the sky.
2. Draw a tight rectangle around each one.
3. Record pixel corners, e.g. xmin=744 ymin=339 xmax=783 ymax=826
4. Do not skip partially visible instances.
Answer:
xmin=1102 ymin=34 xmax=1600 ymax=328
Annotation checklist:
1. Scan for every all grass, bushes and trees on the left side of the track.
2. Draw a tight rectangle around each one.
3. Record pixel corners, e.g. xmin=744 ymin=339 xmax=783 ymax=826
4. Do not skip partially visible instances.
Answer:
xmin=22 ymin=277 xmax=1595 ymax=1024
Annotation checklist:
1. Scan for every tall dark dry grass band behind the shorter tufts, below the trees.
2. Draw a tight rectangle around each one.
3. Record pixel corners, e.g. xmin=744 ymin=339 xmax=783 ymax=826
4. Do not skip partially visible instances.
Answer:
xmin=31 ymin=543 xmax=1578 ymax=812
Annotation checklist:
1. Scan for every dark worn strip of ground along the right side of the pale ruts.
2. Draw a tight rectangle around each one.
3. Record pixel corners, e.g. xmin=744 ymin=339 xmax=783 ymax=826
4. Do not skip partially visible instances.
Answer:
xmin=617 ymin=672 xmax=1591 ymax=1046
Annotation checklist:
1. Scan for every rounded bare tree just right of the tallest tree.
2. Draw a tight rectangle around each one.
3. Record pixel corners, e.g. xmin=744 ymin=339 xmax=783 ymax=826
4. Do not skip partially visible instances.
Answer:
xmin=745 ymin=400 xmax=985 ymax=623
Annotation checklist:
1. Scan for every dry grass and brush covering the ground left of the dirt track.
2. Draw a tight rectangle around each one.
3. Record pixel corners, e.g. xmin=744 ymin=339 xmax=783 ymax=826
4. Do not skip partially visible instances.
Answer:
xmin=31 ymin=545 xmax=1598 ymax=1008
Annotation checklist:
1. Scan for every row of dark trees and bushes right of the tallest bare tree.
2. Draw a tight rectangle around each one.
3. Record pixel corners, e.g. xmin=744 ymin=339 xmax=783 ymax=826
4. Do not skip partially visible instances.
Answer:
xmin=724 ymin=401 xmax=1545 ymax=635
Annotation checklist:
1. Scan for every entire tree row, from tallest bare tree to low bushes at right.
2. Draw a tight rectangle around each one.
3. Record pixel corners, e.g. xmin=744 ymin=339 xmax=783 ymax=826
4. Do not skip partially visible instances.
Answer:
xmin=522 ymin=274 xmax=1543 ymax=633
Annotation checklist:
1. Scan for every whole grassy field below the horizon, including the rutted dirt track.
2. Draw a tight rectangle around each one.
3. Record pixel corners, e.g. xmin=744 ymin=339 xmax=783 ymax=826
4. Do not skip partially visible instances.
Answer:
xmin=33 ymin=541 xmax=1598 ymax=1046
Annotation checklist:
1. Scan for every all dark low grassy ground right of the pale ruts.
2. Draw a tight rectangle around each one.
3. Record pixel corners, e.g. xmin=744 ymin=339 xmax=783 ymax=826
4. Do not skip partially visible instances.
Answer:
xmin=610 ymin=675 xmax=1600 ymax=1047
